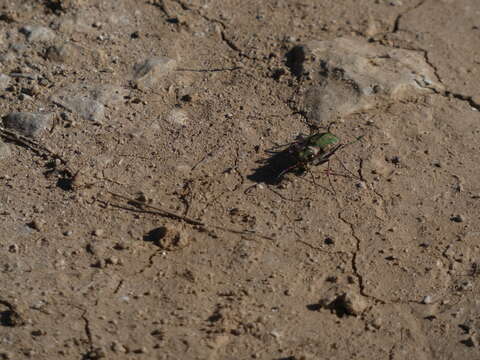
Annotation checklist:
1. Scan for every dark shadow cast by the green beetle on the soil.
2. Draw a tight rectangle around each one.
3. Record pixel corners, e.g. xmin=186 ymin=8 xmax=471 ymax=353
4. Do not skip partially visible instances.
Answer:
xmin=247 ymin=149 xmax=301 ymax=185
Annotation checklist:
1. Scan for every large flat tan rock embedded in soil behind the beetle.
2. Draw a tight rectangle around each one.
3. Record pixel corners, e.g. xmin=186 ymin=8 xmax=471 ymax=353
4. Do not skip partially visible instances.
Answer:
xmin=298 ymin=38 xmax=443 ymax=125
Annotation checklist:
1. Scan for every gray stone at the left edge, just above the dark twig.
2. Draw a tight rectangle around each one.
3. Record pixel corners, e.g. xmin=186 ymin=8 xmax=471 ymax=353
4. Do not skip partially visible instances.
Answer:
xmin=3 ymin=112 xmax=53 ymax=137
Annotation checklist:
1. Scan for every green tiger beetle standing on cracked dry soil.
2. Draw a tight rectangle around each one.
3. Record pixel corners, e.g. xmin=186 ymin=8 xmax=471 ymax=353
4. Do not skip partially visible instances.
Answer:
xmin=277 ymin=131 xmax=363 ymax=178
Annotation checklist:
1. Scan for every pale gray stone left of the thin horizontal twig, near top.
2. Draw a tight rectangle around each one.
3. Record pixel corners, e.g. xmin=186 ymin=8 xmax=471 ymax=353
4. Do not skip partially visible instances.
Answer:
xmin=133 ymin=57 xmax=177 ymax=90
